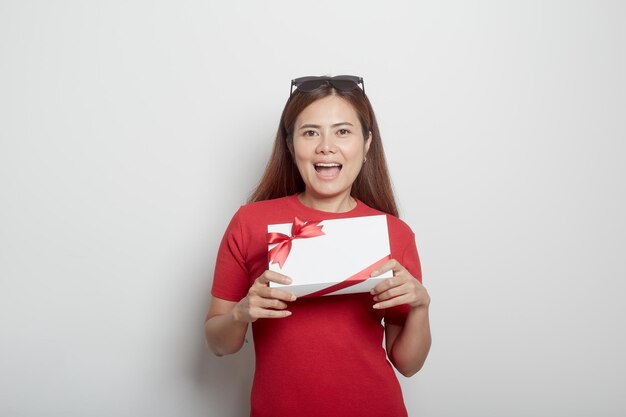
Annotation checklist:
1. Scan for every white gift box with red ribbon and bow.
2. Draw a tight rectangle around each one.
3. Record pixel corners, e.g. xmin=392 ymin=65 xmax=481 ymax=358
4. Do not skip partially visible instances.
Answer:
xmin=267 ymin=215 xmax=393 ymax=297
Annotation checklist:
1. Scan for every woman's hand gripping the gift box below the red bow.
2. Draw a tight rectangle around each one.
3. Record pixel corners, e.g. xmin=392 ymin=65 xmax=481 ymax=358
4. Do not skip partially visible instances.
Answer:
xmin=234 ymin=270 xmax=296 ymax=323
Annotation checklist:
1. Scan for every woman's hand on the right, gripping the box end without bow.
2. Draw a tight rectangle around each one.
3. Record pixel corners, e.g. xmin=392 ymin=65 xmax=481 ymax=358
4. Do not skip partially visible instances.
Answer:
xmin=370 ymin=259 xmax=430 ymax=309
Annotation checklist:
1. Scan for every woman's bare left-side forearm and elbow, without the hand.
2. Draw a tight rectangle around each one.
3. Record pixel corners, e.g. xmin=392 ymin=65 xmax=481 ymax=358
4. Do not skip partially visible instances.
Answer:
xmin=204 ymin=308 xmax=248 ymax=356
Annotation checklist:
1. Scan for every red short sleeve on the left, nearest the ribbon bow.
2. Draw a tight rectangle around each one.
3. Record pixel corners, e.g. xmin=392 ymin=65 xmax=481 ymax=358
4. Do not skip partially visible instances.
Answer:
xmin=211 ymin=209 xmax=250 ymax=301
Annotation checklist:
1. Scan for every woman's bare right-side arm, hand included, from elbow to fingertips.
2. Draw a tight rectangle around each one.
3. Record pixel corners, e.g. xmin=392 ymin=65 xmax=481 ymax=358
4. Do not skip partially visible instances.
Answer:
xmin=371 ymin=259 xmax=431 ymax=377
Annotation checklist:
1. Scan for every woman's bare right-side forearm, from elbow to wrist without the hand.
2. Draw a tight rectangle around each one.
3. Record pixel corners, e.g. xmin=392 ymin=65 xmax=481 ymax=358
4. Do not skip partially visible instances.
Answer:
xmin=389 ymin=305 xmax=431 ymax=377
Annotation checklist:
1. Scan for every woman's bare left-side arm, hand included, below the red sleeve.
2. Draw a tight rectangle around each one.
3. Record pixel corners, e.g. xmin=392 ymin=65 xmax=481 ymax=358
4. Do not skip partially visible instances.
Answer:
xmin=204 ymin=271 xmax=296 ymax=356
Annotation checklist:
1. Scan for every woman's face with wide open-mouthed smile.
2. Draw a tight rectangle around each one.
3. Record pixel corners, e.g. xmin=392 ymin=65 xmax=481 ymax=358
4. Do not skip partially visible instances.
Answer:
xmin=293 ymin=96 xmax=372 ymax=205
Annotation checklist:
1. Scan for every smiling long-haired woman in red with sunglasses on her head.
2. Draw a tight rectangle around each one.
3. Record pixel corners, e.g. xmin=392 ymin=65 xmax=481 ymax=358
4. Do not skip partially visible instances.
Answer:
xmin=205 ymin=76 xmax=431 ymax=417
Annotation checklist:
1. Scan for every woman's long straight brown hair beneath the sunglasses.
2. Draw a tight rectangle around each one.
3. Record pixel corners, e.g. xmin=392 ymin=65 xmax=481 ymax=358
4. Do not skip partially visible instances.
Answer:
xmin=248 ymin=83 xmax=398 ymax=216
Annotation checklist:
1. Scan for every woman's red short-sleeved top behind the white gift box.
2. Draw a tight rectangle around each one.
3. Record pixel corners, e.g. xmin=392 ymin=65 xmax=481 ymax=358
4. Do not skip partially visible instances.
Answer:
xmin=212 ymin=195 xmax=421 ymax=417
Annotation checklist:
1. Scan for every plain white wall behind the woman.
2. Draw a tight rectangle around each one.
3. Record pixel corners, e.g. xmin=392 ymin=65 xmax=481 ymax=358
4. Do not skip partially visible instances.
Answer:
xmin=0 ymin=0 xmax=626 ymax=417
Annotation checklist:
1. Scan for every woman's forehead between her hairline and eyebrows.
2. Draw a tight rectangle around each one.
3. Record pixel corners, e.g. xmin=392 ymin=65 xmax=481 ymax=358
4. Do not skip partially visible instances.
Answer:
xmin=296 ymin=96 xmax=360 ymax=128
